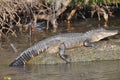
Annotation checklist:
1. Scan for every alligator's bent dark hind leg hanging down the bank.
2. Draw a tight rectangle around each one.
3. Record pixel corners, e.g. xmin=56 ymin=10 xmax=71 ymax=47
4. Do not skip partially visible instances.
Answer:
xmin=59 ymin=43 xmax=71 ymax=63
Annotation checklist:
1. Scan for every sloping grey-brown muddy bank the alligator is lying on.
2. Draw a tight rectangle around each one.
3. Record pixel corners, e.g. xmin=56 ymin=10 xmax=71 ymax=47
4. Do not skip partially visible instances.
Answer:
xmin=29 ymin=39 xmax=120 ymax=64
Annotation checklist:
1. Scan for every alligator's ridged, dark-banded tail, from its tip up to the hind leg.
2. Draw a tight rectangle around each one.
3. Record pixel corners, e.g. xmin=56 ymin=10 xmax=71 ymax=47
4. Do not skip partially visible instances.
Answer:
xmin=9 ymin=39 xmax=60 ymax=67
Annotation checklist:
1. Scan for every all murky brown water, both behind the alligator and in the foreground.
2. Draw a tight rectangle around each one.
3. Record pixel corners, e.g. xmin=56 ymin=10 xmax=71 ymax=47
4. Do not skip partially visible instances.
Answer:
xmin=0 ymin=19 xmax=120 ymax=80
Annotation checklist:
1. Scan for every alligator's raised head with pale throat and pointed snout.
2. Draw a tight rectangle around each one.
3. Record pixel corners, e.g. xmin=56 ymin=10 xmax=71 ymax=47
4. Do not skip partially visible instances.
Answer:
xmin=85 ymin=28 xmax=118 ymax=42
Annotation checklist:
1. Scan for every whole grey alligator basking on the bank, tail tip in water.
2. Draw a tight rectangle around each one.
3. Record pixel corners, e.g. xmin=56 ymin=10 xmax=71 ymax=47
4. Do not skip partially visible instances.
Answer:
xmin=9 ymin=28 xmax=118 ymax=66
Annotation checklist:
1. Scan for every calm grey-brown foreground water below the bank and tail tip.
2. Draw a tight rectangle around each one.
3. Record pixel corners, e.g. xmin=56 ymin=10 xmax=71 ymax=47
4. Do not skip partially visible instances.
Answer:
xmin=0 ymin=61 xmax=120 ymax=80
